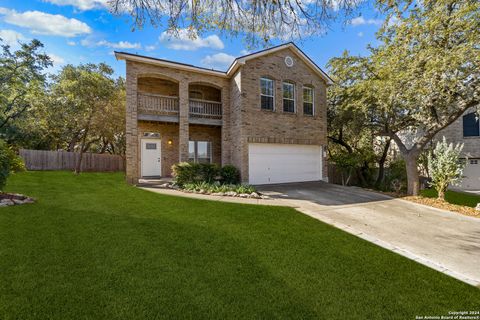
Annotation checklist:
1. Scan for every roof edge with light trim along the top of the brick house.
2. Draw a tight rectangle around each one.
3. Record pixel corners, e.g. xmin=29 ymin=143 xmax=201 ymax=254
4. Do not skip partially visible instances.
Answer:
xmin=115 ymin=42 xmax=333 ymax=85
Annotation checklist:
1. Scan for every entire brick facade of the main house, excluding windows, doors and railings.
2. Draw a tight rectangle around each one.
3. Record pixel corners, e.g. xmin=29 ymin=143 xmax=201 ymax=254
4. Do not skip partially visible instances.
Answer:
xmin=121 ymin=47 xmax=327 ymax=184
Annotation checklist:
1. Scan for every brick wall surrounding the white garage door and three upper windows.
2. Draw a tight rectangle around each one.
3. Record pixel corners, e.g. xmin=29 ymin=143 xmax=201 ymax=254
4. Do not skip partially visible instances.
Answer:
xmin=232 ymin=48 xmax=328 ymax=181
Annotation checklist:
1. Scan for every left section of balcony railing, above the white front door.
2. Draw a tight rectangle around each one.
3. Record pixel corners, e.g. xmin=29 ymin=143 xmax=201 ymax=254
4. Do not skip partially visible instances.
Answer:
xmin=138 ymin=93 xmax=178 ymax=115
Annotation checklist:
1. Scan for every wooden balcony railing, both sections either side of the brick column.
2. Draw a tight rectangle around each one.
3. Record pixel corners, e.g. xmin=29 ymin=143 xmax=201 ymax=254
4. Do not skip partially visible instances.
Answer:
xmin=137 ymin=92 xmax=222 ymax=125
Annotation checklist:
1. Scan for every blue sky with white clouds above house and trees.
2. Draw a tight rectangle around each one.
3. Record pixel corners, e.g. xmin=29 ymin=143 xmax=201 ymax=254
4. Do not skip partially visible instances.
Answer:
xmin=0 ymin=0 xmax=383 ymax=76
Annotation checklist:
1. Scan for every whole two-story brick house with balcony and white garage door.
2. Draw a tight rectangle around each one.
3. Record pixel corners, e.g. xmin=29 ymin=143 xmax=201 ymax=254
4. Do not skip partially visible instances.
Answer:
xmin=115 ymin=43 xmax=332 ymax=184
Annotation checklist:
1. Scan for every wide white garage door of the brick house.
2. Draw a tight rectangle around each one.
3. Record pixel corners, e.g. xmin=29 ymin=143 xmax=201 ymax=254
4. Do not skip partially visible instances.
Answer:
xmin=248 ymin=143 xmax=322 ymax=184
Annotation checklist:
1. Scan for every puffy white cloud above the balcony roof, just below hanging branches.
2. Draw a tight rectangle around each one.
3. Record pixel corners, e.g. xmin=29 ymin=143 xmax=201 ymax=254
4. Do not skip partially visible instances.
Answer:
xmin=159 ymin=29 xmax=224 ymax=51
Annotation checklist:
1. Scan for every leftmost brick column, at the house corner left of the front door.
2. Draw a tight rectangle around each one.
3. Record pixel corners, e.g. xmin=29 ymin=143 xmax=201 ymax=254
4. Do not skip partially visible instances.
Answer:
xmin=125 ymin=62 xmax=140 ymax=184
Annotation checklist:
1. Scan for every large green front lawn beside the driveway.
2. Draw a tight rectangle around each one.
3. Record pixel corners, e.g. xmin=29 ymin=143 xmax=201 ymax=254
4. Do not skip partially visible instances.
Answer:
xmin=0 ymin=172 xmax=480 ymax=319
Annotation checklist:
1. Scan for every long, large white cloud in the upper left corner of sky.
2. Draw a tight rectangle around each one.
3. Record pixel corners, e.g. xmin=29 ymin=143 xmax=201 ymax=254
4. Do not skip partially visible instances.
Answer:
xmin=0 ymin=8 xmax=92 ymax=37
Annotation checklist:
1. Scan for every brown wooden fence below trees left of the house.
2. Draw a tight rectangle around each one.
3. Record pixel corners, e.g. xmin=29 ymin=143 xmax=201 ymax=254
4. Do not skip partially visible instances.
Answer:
xmin=20 ymin=149 xmax=125 ymax=172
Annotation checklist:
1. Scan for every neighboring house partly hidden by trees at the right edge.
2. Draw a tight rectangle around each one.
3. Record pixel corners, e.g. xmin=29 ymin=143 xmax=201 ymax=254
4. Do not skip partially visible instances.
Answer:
xmin=435 ymin=109 xmax=480 ymax=190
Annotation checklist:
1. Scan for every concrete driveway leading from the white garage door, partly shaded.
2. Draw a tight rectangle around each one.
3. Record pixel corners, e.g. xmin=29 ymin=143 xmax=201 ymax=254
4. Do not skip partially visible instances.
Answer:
xmin=258 ymin=182 xmax=480 ymax=286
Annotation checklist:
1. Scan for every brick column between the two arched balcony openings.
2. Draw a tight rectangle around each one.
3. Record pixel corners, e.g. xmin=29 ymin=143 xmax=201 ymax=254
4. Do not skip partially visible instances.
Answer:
xmin=178 ymin=80 xmax=190 ymax=162
